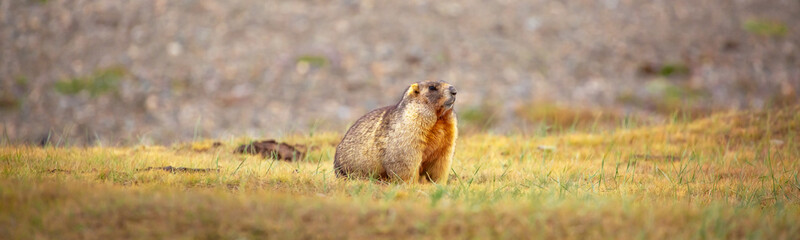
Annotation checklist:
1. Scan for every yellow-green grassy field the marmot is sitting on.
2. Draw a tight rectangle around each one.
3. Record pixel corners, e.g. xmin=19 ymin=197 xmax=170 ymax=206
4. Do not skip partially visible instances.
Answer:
xmin=0 ymin=107 xmax=800 ymax=239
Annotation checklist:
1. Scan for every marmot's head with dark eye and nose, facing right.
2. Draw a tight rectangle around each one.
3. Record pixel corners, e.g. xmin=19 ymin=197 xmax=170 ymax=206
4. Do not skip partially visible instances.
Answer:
xmin=401 ymin=81 xmax=456 ymax=116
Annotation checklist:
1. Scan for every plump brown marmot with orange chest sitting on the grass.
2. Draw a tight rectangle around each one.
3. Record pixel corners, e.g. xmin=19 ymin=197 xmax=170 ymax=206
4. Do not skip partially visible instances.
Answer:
xmin=333 ymin=81 xmax=458 ymax=184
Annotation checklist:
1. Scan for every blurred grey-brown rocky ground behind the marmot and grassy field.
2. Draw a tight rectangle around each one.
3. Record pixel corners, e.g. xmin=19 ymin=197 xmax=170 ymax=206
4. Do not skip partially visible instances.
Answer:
xmin=0 ymin=0 xmax=800 ymax=144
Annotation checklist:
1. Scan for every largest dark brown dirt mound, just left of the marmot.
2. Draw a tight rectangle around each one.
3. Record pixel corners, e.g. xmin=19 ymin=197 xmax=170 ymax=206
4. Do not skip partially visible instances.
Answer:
xmin=233 ymin=139 xmax=308 ymax=161
